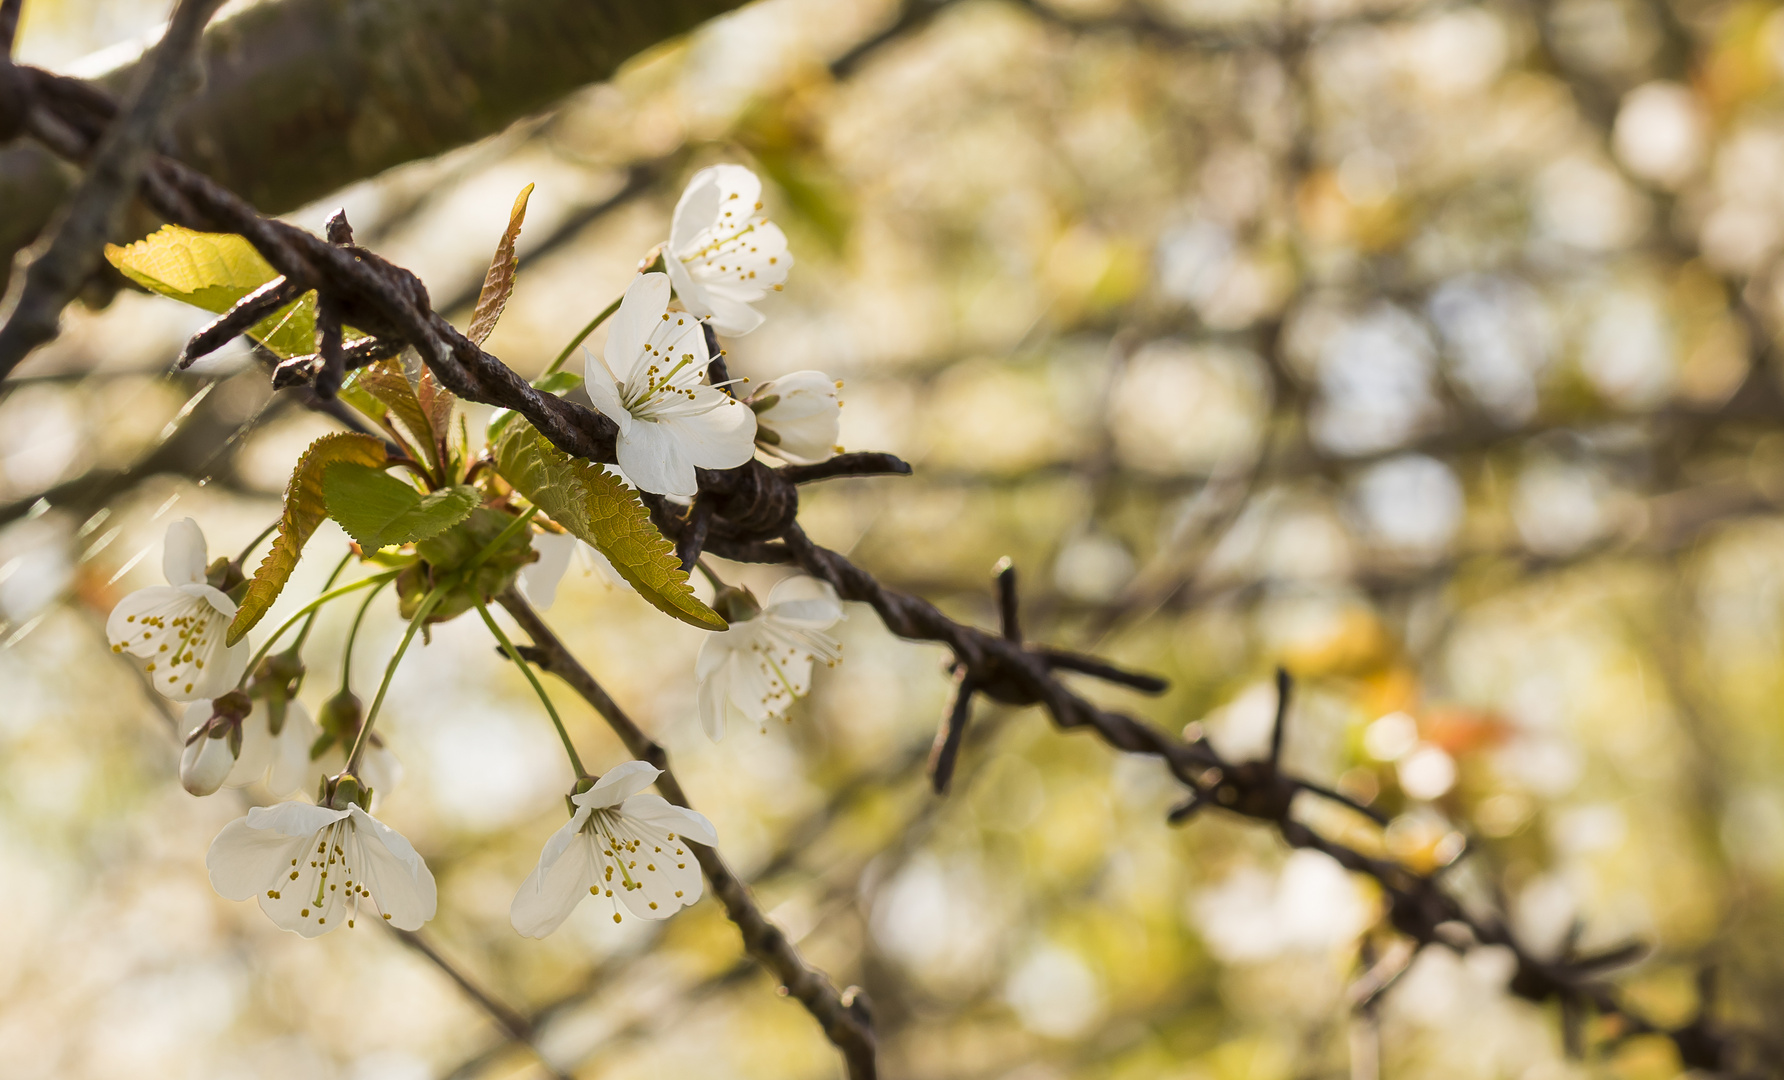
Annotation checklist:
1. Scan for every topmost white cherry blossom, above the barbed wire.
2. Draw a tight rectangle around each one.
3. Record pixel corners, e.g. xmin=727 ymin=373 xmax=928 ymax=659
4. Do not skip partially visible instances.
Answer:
xmin=662 ymin=164 xmax=792 ymax=337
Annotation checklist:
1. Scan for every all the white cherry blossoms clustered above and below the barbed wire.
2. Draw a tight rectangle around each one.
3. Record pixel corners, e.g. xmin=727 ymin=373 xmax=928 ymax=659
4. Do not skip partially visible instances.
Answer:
xmin=107 ymin=164 xmax=844 ymax=937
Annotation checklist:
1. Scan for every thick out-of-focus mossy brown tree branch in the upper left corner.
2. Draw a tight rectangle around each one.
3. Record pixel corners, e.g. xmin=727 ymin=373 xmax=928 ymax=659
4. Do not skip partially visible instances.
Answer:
xmin=0 ymin=0 xmax=742 ymax=280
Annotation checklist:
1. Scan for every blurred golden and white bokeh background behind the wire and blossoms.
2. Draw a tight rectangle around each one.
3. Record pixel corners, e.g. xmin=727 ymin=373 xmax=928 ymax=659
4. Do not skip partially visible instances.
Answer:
xmin=0 ymin=0 xmax=1784 ymax=1080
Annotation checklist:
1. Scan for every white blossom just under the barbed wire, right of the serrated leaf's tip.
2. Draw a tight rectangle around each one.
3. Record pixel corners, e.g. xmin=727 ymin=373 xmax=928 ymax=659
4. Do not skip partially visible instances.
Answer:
xmin=694 ymin=577 xmax=842 ymax=743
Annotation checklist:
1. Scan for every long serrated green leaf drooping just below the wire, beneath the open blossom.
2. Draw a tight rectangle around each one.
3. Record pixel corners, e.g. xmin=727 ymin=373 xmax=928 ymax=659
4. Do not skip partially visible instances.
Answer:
xmin=496 ymin=416 xmax=726 ymax=630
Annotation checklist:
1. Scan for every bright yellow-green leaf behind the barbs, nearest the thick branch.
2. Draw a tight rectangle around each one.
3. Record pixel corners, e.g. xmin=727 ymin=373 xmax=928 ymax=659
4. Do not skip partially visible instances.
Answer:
xmin=105 ymin=225 xmax=316 ymax=357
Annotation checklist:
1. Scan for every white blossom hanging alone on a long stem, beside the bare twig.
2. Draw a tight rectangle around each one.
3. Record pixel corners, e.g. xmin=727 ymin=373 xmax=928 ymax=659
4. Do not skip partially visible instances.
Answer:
xmin=508 ymin=760 xmax=719 ymax=937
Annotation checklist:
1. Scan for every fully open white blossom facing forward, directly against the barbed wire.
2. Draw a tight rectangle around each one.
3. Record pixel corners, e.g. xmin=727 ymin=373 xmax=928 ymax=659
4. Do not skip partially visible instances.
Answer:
xmin=583 ymin=273 xmax=756 ymax=496
